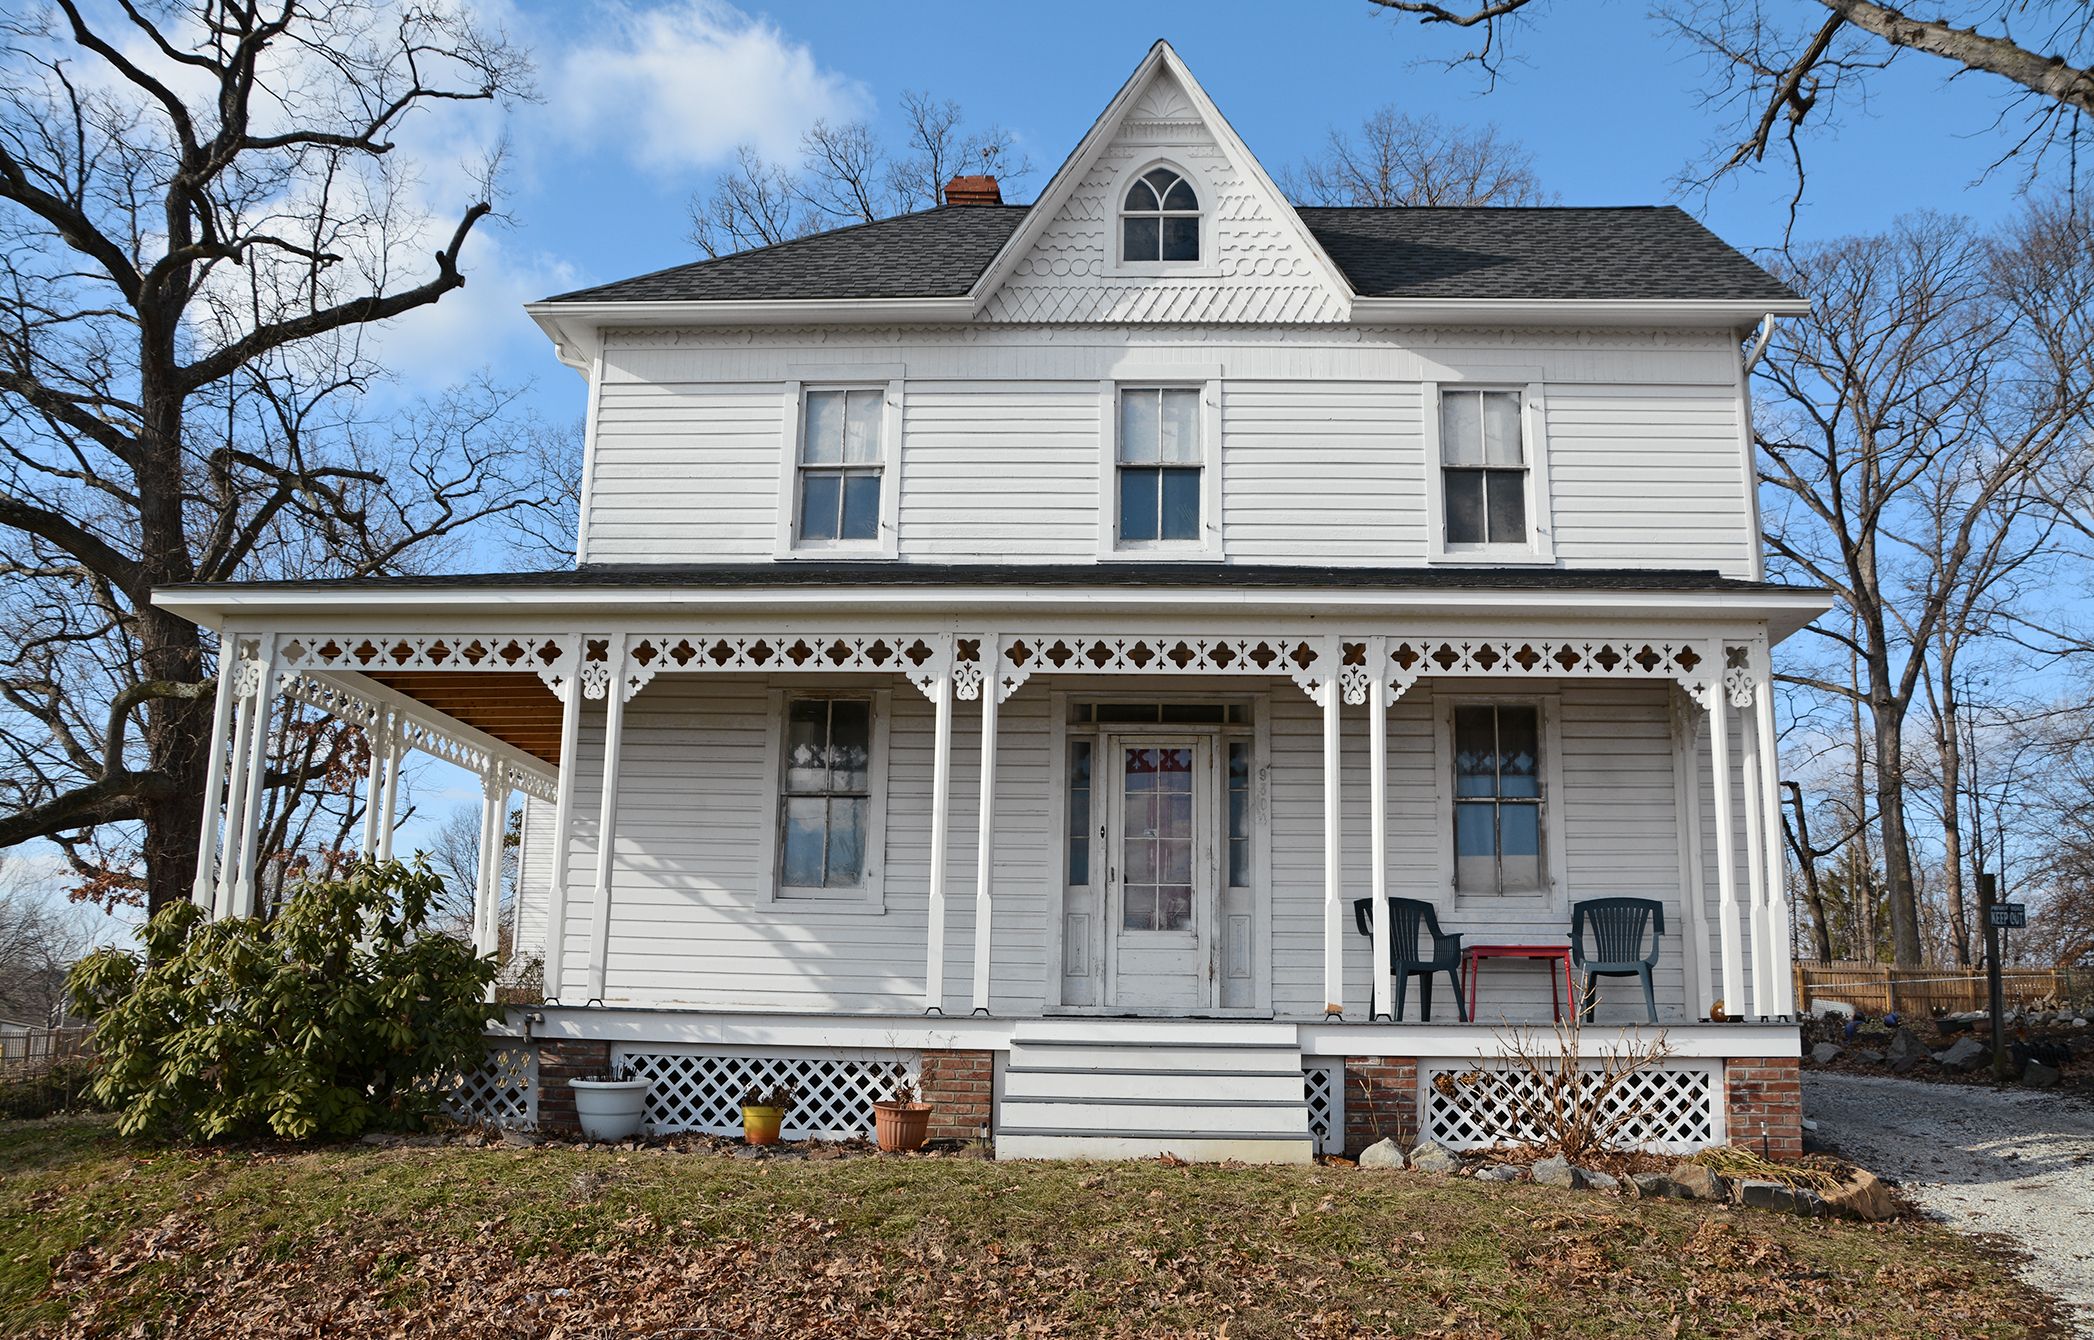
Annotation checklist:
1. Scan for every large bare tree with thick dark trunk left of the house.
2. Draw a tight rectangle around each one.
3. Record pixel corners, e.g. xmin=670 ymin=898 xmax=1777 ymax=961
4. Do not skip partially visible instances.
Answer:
xmin=0 ymin=0 xmax=548 ymax=909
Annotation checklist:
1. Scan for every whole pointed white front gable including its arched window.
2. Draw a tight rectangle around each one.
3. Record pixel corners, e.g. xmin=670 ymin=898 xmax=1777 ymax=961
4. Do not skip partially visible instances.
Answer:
xmin=974 ymin=42 xmax=1353 ymax=325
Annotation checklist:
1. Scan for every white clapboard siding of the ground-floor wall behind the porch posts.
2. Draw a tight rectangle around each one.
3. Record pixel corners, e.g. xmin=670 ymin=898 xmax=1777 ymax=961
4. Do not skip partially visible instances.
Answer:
xmin=561 ymin=676 xmax=1713 ymax=1022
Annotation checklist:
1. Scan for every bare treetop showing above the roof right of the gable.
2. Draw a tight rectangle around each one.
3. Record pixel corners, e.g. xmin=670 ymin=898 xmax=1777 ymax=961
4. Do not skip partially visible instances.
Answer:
xmin=1279 ymin=107 xmax=1554 ymax=205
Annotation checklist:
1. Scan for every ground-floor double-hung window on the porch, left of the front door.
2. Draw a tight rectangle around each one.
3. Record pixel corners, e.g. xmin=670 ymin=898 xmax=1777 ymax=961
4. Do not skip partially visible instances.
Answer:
xmin=779 ymin=697 xmax=873 ymax=896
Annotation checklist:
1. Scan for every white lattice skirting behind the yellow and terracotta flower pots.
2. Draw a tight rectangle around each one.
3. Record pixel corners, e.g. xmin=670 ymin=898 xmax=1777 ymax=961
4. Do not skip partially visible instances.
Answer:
xmin=611 ymin=1045 xmax=921 ymax=1139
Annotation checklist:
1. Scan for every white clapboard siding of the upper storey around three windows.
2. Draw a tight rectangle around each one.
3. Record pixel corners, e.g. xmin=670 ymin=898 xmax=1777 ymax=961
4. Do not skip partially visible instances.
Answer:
xmin=584 ymin=325 xmax=1753 ymax=576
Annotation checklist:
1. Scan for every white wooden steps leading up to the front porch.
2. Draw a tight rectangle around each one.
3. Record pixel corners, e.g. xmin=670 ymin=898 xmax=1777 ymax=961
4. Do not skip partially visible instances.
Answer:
xmin=995 ymin=1018 xmax=1315 ymax=1162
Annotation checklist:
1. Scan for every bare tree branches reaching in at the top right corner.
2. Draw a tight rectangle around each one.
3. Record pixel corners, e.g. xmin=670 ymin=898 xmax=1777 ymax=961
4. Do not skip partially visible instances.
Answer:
xmin=1374 ymin=0 xmax=2094 ymax=205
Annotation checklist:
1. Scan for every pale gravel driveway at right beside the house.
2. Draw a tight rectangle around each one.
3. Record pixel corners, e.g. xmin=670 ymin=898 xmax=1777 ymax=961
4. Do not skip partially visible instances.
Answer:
xmin=1803 ymin=1070 xmax=2094 ymax=1336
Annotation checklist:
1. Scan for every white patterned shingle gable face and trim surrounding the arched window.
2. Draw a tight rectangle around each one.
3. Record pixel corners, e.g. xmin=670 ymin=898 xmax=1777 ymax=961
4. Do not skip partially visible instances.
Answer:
xmin=970 ymin=42 xmax=1355 ymax=325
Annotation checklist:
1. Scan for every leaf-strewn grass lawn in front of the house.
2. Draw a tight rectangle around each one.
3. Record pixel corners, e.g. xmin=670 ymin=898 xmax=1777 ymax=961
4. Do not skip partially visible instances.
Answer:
xmin=0 ymin=1118 xmax=2058 ymax=1340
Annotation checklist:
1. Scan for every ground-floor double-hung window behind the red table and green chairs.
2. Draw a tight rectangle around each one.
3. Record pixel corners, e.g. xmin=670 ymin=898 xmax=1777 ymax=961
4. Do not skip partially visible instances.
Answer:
xmin=1453 ymin=704 xmax=1545 ymax=894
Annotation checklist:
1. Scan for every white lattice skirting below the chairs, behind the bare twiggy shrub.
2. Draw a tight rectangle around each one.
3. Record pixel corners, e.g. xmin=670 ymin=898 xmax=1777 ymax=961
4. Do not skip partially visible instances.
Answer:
xmin=1418 ymin=1059 xmax=1725 ymax=1154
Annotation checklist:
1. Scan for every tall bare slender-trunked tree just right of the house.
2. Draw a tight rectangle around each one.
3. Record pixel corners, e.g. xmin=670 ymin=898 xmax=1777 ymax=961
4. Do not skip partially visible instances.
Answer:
xmin=1757 ymin=207 xmax=2094 ymax=963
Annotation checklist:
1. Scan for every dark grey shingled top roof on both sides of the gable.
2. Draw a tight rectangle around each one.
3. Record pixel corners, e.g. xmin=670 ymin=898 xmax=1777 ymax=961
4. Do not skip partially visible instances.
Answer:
xmin=547 ymin=205 xmax=1795 ymax=302
